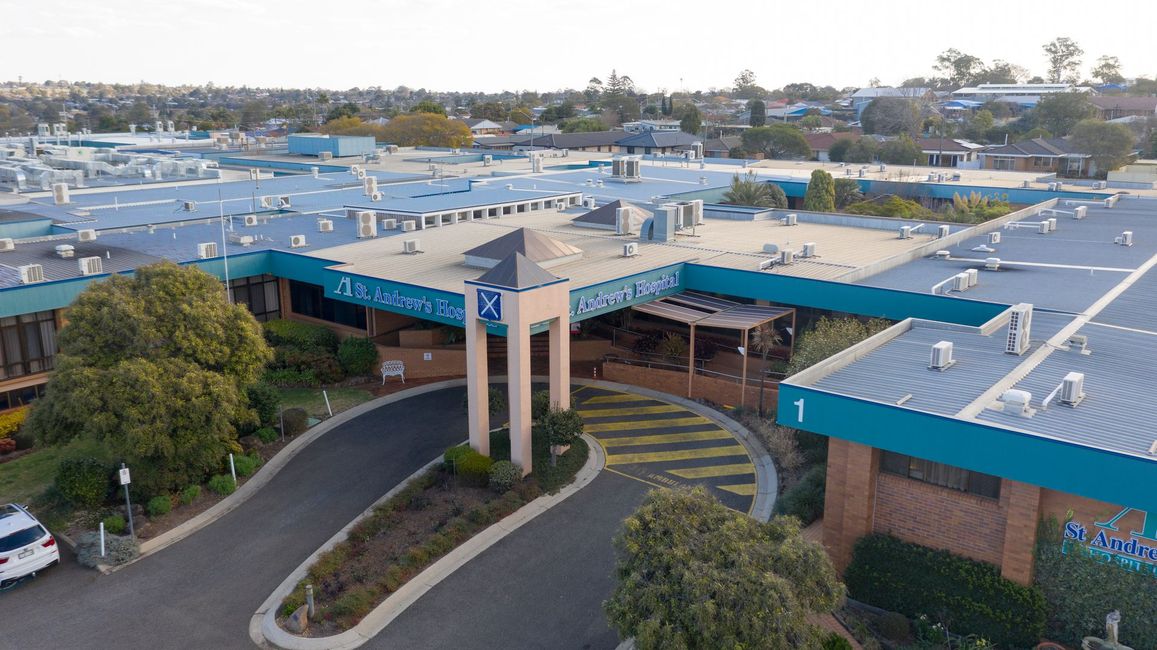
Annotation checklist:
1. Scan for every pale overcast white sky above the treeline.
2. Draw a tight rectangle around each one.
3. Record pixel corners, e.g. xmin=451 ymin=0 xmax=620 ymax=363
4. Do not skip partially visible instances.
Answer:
xmin=9 ymin=0 xmax=1157 ymax=91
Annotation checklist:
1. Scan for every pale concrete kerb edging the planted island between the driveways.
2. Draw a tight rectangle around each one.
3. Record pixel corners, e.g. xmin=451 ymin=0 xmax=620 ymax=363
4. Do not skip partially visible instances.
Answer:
xmin=249 ymin=435 xmax=606 ymax=650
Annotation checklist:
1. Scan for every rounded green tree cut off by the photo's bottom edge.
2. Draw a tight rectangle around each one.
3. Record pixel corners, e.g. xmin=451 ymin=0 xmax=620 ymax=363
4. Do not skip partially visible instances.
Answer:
xmin=603 ymin=488 xmax=843 ymax=650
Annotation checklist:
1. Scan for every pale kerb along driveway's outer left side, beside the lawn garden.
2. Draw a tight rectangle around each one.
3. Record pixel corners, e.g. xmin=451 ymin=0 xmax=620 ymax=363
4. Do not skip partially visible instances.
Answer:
xmin=100 ymin=379 xmax=466 ymax=575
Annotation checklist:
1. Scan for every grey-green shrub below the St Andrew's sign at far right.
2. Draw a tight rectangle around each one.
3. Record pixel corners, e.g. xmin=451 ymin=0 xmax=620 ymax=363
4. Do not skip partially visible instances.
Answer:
xmin=1037 ymin=515 xmax=1157 ymax=649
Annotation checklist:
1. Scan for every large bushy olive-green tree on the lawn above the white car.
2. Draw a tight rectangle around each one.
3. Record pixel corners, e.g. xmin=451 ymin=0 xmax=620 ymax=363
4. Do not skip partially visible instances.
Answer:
xmin=25 ymin=263 xmax=273 ymax=492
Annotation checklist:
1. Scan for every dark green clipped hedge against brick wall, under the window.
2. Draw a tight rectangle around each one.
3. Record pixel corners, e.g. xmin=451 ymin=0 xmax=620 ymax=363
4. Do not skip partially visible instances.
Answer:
xmin=845 ymin=534 xmax=1045 ymax=648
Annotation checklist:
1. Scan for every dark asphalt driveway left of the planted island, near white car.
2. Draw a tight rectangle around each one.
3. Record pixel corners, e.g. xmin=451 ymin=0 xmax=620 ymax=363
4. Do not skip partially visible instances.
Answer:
xmin=0 ymin=389 xmax=466 ymax=650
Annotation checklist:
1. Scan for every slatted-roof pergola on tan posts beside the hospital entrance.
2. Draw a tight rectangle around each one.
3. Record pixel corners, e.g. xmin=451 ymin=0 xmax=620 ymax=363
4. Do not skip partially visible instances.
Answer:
xmin=632 ymin=291 xmax=796 ymax=406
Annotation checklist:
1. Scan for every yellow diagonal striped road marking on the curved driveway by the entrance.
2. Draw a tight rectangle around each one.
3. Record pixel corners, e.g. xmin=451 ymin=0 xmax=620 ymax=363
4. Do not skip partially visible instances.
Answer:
xmin=570 ymin=386 xmax=757 ymax=514
